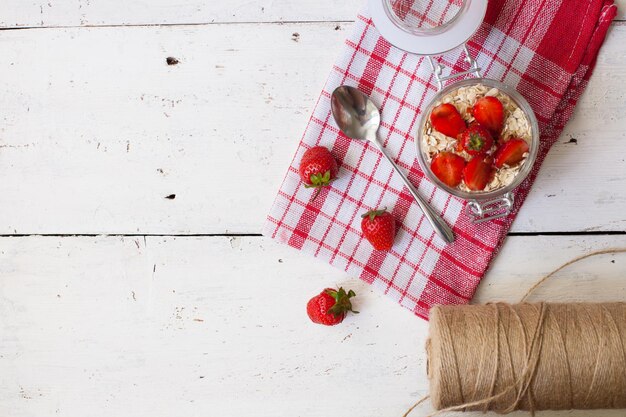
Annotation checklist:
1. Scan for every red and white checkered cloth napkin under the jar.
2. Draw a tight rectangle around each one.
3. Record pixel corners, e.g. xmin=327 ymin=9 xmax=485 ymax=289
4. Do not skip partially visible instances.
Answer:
xmin=264 ymin=0 xmax=616 ymax=318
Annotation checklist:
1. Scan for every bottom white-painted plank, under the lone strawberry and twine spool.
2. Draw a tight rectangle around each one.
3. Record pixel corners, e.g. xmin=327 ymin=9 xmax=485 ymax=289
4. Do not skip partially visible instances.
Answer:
xmin=0 ymin=236 xmax=626 ymax=417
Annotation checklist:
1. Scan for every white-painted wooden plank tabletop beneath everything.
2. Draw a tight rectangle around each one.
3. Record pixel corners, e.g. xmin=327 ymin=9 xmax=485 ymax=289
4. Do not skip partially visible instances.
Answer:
xmin=0 ymin=0 xmax=626 ymax=417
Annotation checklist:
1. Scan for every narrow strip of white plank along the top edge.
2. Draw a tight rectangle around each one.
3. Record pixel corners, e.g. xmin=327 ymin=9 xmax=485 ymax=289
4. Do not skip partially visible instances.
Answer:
xmin=0 ymin=0 xmax=626 ymax=28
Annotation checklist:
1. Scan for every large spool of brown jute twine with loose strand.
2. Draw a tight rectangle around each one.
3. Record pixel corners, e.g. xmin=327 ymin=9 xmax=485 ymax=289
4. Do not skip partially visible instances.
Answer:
xmin=404 ymin=249 xmax=626 ymax=417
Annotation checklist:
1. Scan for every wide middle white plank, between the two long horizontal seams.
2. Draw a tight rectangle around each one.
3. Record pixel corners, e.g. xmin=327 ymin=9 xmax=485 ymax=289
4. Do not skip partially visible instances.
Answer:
xmin=0 ymin=23 xmax=626 ymax=234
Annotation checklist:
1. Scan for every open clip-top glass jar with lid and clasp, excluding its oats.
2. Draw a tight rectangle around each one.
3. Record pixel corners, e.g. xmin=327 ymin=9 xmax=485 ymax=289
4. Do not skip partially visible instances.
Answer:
xmin=369 ymin=0 xmax=539 ymax=223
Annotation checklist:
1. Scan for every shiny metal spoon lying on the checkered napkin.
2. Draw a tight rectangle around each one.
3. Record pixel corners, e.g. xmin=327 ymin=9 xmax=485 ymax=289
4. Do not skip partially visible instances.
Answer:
xmin=331 ymin=85 xmax=454 ymax=243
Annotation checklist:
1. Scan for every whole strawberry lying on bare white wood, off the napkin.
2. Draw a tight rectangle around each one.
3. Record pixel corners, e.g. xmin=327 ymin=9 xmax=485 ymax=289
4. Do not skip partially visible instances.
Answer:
xmin=306 ymin=287 xmax=358 ymax=326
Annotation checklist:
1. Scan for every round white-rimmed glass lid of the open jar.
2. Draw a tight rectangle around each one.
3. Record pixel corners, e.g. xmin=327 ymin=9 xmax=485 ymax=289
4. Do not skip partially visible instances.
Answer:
xmin=369 ymin=0 xmax=487 ymax=55
